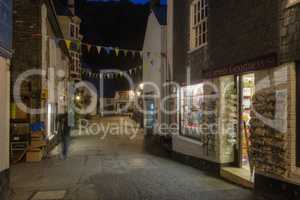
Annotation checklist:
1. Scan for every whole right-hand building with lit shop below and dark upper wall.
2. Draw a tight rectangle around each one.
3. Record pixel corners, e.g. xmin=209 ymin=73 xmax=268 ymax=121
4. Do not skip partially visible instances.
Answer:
xmin=168 ymin=0 xmax=300 ymax=195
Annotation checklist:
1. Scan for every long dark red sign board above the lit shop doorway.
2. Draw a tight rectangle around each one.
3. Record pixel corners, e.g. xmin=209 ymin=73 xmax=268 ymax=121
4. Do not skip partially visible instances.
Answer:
xmin=203 ymin=54 xmax=277 ymax=78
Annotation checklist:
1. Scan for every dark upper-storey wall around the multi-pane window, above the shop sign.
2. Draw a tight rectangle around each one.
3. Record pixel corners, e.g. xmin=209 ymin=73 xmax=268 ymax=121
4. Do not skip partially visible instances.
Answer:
xmin=174 ymin=0 xmax=280 ymax=83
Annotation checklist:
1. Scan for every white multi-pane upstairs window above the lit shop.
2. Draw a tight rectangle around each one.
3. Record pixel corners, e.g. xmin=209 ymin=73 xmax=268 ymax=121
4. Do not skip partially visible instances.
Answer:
xmin=190 ymin=0 xmax=208 ymax=50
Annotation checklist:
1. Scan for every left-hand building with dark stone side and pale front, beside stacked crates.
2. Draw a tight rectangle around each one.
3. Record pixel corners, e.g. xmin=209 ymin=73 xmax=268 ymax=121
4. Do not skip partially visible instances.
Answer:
xmin=11 ymin=0 xmax=71 ymax=147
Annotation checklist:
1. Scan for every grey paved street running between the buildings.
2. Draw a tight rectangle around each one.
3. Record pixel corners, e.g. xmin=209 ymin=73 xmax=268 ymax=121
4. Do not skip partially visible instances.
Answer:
xmin=11 ymin=117 xmax=255 ymax=200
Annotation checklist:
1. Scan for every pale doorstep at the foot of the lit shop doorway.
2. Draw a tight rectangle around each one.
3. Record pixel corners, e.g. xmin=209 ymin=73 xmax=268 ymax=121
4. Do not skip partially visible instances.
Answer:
xmin=220 ymin=167 xmax=254 ymax=189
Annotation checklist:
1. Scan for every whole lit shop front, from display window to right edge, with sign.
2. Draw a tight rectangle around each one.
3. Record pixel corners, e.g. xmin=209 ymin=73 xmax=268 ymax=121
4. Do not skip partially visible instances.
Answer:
xmin=173 ymin=55 xmax=297 ymax=187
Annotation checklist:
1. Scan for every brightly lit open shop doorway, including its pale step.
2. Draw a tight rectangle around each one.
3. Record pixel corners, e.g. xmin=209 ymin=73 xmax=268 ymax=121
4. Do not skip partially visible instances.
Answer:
xmin=221 ymin=73 xmax=255 ymax=187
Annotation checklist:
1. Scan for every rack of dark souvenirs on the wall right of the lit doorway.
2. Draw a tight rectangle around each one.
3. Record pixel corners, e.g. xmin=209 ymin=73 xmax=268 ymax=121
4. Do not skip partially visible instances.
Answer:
xmin=250 ymin=89 xmax=288 ymax=176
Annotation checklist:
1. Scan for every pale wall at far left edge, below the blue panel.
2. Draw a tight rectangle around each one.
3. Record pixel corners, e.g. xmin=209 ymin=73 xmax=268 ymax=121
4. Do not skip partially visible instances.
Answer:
xmin=0 ymin=57 xmax=10 ymax=171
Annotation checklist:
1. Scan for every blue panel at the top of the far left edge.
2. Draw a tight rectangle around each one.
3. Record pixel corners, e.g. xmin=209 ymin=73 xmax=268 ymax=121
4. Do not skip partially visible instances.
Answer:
xmin=0 ymin=0 xmax=12 ymax=54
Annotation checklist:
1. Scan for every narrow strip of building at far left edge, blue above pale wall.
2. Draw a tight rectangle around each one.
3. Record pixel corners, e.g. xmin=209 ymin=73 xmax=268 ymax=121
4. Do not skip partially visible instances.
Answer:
xmin=0 ymin=0 xmax=13 ymax=200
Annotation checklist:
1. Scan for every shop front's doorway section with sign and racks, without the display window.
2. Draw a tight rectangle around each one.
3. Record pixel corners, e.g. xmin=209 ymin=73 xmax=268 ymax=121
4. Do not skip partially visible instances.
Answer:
xmin=199 ymin=53 xmax=299 ymax=187
